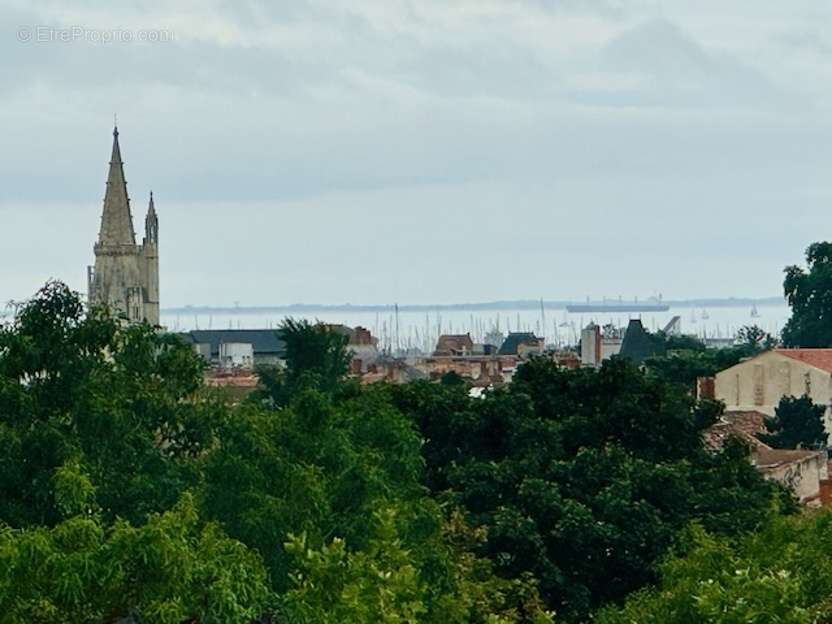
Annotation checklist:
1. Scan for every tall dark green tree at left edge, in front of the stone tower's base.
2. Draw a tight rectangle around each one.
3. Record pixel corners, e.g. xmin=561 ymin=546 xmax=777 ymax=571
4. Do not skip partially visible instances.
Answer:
xmin=0 ymin=282 xmax=213 ymax=527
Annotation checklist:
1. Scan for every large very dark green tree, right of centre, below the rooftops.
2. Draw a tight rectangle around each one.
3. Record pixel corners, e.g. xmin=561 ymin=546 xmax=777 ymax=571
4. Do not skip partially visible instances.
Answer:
xmin=394 ymin=358 xmax=792 ymax=619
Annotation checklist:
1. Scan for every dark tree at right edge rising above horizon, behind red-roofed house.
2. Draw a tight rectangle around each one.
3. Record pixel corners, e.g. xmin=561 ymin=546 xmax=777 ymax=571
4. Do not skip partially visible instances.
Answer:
xmin=782 ymin=242 xmax=832 ymax=347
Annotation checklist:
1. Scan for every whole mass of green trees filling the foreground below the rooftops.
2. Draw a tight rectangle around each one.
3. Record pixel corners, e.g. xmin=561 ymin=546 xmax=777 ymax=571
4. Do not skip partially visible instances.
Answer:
xmin=0 ymin=283 xmax=820 ymax=624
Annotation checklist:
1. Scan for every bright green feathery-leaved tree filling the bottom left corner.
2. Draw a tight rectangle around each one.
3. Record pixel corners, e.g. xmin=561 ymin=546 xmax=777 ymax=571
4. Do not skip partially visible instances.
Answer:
xmin=0 ymin=495 xmax=274 ymax=624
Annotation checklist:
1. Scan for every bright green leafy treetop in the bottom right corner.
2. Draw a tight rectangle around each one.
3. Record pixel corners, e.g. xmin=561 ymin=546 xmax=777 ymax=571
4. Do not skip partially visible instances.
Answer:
xmin=597 ymin=512 xmax=832 ymax=624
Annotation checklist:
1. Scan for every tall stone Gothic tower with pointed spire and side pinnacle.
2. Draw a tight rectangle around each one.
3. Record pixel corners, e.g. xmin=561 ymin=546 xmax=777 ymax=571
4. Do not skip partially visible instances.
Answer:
xmin=87 ymin=128 xmax=159 ymax=325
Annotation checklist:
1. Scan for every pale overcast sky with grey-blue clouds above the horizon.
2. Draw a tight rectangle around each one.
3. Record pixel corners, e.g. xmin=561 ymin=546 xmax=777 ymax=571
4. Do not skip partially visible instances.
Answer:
xmin=0 ymin=0 xmax=832 ymax=307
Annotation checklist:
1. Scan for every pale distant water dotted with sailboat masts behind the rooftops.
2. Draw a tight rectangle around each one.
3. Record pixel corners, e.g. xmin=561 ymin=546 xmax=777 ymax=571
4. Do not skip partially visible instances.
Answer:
xmin=162 ymin=304 xmax=790 ymax=351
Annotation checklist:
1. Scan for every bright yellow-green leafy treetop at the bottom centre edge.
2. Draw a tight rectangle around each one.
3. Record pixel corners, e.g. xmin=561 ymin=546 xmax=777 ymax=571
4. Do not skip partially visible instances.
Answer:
xmin=283 ymin=508 xmax=553 ymax=624
